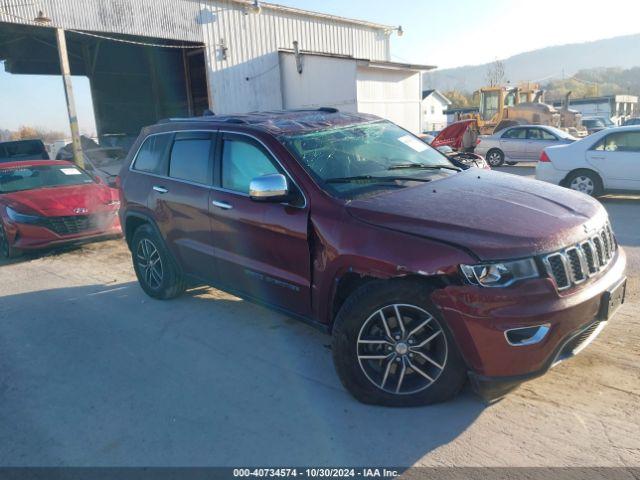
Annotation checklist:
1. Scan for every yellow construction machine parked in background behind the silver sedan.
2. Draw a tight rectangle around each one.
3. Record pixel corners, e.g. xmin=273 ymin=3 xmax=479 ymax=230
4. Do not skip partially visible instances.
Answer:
xmin=461 ymin=84 xmax=586 ymax=136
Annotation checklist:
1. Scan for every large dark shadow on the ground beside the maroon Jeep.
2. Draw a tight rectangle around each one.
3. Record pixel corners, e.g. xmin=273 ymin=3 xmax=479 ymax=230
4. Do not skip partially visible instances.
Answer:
xmin=0 ymin=283 xmax=484 ymax=466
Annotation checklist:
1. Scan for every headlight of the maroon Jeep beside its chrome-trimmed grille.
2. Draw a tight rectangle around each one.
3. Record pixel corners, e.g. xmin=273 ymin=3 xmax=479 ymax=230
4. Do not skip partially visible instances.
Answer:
xmin=460 ymin=258 xmax=540 ymax=287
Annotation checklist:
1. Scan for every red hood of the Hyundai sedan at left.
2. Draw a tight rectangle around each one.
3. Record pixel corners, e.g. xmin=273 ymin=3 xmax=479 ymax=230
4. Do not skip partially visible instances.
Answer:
xmin=2 ymin=184 xmax=118 ymax=216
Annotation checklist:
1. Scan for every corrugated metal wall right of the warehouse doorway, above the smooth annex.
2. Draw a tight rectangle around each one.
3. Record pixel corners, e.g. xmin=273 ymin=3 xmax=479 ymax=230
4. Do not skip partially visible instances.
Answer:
xmin=201 ymin=0 xmax=389 ymax=113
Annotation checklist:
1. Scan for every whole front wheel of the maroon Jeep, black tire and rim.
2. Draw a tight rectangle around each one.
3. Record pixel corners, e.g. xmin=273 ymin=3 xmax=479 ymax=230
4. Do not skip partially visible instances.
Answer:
xmin=332 ymin=280 xmax=467 ymax=407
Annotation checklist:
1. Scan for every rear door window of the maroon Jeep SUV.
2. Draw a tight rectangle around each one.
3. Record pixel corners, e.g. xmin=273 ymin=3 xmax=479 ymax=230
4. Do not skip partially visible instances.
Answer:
xmin=169 ymin=132 xmax=213 ymax=185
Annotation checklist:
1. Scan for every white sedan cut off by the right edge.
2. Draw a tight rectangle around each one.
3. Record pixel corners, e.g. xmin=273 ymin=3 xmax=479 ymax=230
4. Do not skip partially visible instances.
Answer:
xmin=536 ymin=126 xmax=640 ymax=196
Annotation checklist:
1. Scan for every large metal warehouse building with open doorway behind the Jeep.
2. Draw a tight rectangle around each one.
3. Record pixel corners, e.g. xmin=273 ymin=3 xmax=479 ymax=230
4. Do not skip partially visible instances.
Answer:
xmin=0 ymin=0 xmax=431 ymax=150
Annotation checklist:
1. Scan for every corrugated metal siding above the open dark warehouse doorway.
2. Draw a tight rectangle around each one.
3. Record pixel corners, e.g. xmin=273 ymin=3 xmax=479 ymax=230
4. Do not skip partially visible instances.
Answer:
xmin=0 ymin=0 xmax=202 ymax=42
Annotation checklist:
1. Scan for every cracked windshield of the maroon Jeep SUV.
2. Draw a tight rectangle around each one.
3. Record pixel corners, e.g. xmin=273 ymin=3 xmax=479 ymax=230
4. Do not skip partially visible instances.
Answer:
xmin=280 ymin=121 xmax=457 ymax=196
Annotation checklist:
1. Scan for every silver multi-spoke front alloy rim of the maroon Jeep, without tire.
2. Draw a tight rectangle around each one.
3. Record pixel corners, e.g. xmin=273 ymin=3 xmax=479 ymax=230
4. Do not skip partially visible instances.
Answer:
xmin=357 ymin=304 xmax=448 ymax=395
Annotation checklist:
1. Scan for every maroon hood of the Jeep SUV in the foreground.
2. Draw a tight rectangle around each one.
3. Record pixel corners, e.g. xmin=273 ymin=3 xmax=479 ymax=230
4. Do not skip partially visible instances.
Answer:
xmin=347 ymin=169 xmax=607 ymax=260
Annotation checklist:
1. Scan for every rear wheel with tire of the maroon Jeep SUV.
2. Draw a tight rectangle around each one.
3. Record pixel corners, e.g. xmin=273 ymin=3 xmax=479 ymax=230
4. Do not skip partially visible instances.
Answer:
xmin=131 ymin=224 xmax=185 ymax=300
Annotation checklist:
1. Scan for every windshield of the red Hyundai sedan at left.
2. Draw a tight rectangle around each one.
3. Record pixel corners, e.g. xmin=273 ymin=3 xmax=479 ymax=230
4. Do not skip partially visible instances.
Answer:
xmin=0 ymin=165 xmax=94 ymax=193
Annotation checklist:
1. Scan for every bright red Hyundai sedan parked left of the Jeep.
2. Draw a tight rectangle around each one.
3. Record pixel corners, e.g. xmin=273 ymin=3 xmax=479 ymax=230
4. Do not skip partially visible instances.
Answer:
xmin=0 ymin=160 xmax=121 ymax=257
